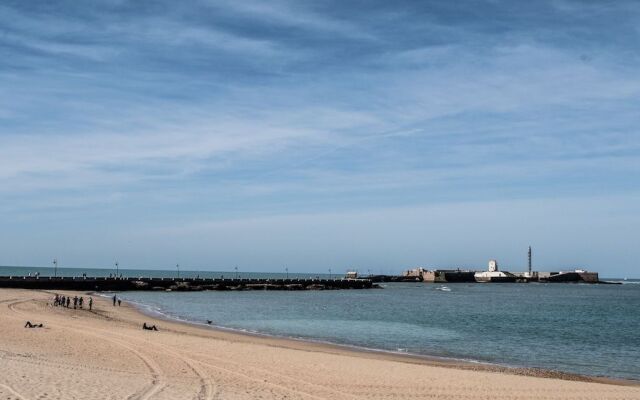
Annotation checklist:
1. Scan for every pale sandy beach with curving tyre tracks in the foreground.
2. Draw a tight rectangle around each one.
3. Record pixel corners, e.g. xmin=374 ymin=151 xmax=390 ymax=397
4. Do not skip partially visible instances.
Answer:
xmin=0 ymin=289 xmax=640 ymax=400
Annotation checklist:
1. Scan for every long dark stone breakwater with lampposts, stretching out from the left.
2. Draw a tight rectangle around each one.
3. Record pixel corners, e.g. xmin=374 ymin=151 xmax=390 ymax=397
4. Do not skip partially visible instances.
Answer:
xmin=0 ymin=276 xmax=377 ymax=291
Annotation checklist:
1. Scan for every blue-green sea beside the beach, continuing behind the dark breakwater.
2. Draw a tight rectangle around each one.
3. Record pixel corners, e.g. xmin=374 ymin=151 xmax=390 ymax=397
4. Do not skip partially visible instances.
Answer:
xmin=0 ymin=267 xmax=640 ymax=380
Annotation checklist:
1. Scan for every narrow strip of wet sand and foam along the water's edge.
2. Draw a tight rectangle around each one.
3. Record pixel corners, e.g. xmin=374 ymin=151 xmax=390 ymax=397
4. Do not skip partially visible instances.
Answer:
xmin=109 ymin=292 xmax=640 ymax=387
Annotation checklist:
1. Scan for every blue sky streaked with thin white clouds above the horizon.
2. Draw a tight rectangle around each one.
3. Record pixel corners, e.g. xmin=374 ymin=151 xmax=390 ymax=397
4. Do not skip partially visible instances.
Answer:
xmin=0 ymin=0 xmax=640 ymax=277
